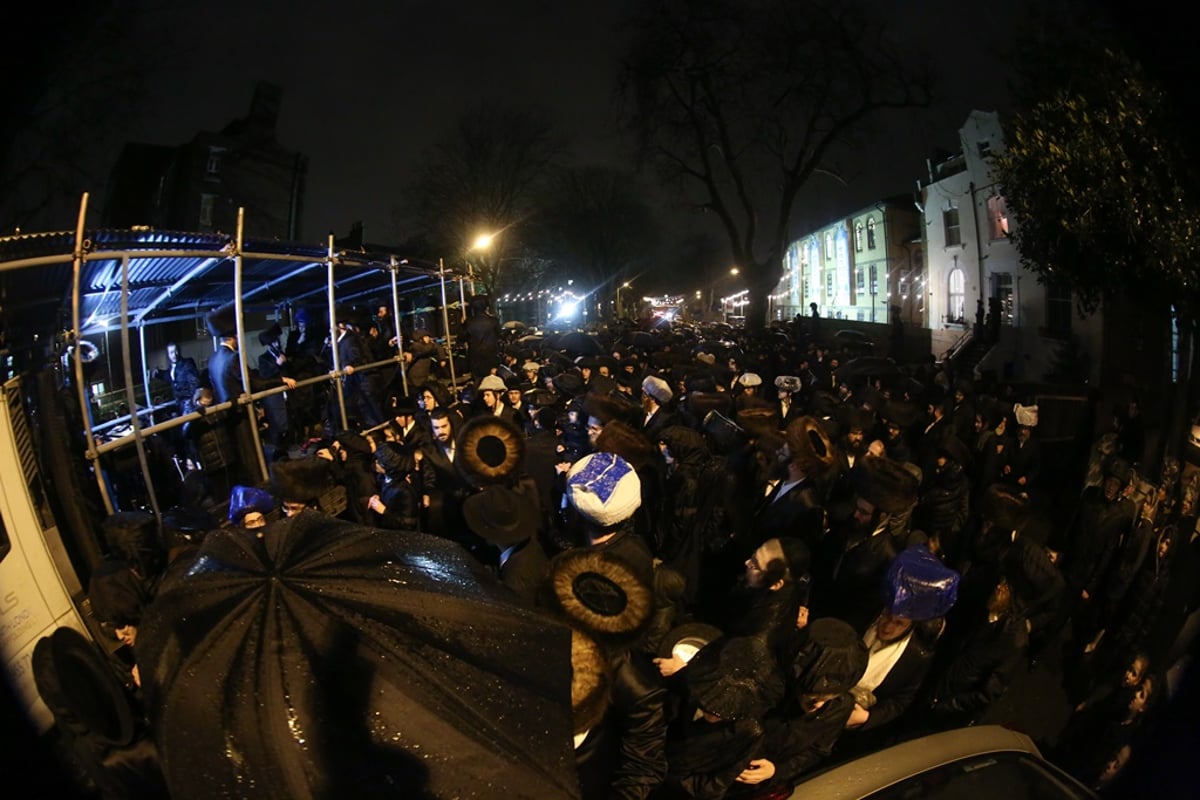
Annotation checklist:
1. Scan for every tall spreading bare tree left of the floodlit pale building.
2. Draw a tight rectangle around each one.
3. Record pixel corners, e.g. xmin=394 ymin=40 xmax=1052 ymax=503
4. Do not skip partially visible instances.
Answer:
xmin=620 ymin=0 xmax=930 ymax=326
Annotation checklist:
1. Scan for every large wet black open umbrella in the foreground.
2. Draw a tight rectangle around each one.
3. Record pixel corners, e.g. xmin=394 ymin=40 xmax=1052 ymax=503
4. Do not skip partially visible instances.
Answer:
xmin=138 ymin=511 xmax=578 ymax=800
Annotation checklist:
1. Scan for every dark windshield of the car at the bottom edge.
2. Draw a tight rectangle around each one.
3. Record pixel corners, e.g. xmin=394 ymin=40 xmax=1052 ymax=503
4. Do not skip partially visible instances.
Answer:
xmin=869 ymin=753 xmax=1093 ymax=800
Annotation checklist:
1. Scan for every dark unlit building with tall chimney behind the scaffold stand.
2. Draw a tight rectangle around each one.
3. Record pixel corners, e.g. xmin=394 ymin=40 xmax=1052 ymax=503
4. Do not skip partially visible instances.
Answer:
xmin=103 ymin=83 xmax=308 ymax=241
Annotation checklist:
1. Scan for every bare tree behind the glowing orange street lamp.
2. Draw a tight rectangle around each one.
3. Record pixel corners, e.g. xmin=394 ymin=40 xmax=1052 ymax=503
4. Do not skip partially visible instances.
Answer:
xmin=407 ymin=106 xmax=565 ymax=295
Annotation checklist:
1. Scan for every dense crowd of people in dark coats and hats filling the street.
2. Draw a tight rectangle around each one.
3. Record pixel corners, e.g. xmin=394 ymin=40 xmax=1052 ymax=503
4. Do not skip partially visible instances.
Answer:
xmin=77 ymin=306 xmax=1200 ymax=799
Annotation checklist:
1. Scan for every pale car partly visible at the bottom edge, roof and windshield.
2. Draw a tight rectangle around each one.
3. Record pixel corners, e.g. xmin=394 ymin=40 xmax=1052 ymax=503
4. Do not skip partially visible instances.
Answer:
xmin=790 ymin=726 xmax=1098 ymax=800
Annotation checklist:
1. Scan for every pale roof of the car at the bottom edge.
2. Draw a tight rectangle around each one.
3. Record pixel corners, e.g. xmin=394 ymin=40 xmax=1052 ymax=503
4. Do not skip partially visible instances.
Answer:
xmin=792 ymin=726 xmax=1042 ymax=800
